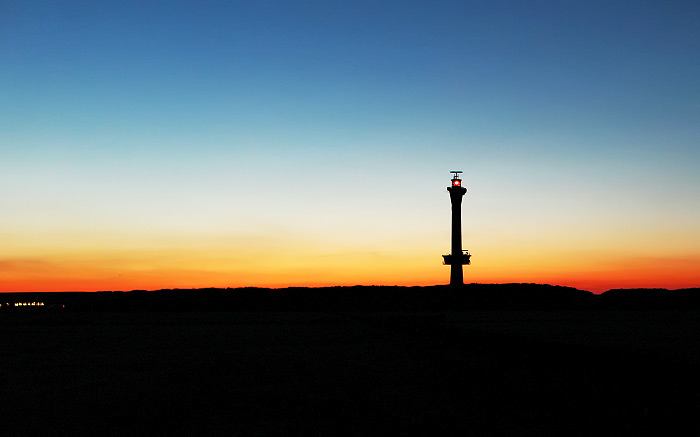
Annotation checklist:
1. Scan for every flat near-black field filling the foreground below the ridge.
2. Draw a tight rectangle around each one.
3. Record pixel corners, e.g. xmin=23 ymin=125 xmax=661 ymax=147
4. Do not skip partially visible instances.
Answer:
xmin=0 ymin=310 xmax=700 ymax=435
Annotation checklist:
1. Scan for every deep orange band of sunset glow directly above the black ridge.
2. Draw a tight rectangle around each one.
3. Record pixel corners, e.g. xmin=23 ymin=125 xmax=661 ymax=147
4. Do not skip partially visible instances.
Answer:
xmin=0 ymin=245 xmax=700 ymax=293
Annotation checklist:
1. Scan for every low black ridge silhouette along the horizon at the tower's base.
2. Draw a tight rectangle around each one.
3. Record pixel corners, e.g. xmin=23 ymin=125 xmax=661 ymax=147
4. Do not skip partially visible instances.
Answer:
xmin=0 ymin=284 xmax=700 ymax=311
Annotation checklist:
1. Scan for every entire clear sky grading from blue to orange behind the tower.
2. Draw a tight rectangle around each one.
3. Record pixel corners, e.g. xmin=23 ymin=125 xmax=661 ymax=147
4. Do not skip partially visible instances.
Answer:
xmin=0 ymin=0 xmax=700 ymax=292
